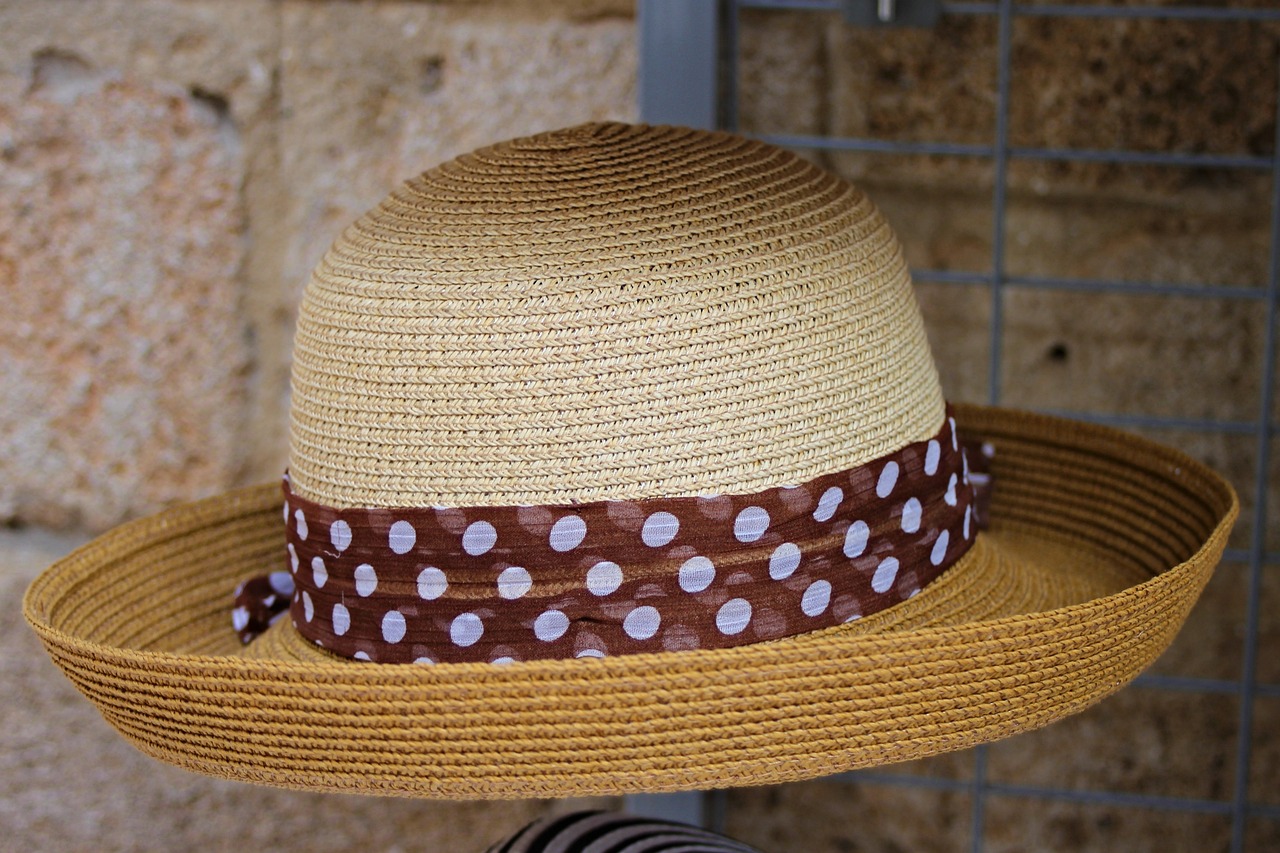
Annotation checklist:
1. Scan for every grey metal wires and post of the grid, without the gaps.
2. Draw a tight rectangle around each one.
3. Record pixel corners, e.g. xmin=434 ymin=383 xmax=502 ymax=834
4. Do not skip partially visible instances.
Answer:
xmin=630 ymin=0 xmax=1280 ymax=852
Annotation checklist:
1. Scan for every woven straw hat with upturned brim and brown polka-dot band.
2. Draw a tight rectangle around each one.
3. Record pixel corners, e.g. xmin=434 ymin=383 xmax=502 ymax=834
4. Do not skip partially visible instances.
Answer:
xmin=24 ymin=124 xmax=1236 ymax=798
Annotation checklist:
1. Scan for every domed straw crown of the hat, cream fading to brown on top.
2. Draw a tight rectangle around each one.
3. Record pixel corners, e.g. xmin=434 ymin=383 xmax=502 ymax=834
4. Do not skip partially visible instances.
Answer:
xmin=289 ymin=123 xmax=943 ymax=507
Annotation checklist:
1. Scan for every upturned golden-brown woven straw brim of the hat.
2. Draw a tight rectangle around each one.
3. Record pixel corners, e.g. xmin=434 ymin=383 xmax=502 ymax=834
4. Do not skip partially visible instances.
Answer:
xmin=24 ymin=406 xmax=1238 ymax=799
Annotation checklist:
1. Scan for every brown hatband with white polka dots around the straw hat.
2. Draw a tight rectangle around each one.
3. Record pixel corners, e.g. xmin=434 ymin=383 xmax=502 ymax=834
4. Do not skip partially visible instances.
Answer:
xmin=252 ymin=416 xmax=982 ymax=663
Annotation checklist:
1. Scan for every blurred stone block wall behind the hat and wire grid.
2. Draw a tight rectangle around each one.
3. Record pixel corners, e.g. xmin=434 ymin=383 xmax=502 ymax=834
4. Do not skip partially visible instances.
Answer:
xmin=0 ymin=0 xmax=1280 ymax=853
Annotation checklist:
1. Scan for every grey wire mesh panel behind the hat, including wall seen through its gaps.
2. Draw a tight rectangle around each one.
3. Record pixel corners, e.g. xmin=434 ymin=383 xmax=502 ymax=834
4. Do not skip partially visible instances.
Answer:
xmin=641 ymin=0 xmax=1280 ymax=850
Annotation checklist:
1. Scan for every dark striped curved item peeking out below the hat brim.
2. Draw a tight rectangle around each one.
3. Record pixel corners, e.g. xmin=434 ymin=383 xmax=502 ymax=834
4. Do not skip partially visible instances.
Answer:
xmin=486 ymin=812 xmax=762 ymax=853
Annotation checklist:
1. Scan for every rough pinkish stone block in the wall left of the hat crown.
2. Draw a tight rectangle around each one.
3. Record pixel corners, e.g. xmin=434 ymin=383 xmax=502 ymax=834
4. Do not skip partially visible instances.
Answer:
xmin=0 ymin=63 xmax=248 ymax=528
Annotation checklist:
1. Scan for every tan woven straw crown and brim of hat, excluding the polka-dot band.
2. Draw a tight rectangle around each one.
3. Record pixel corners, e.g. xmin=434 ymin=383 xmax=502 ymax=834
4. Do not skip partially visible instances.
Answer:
xmin=24 ymin=124 xmax=1238 ymax=798
